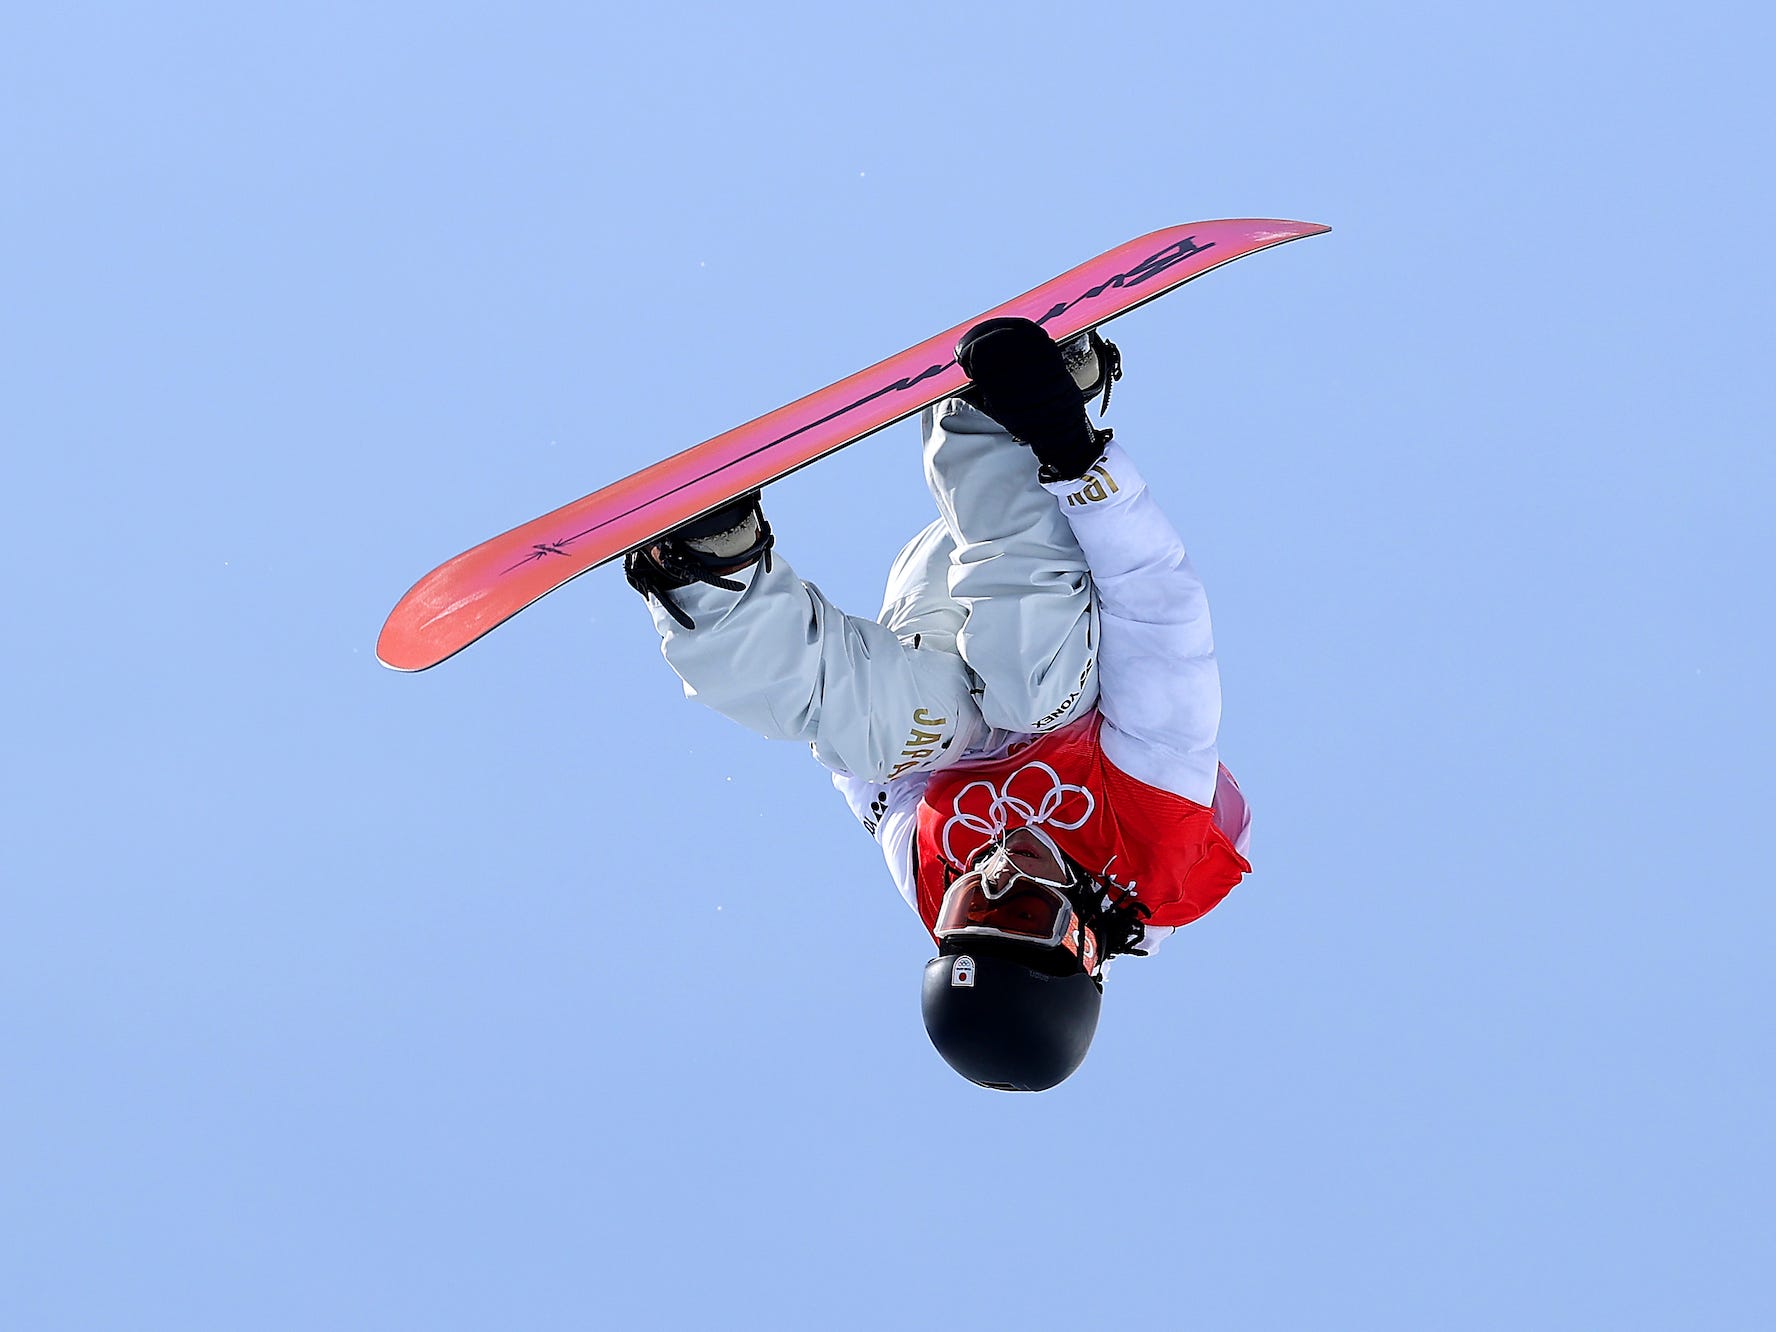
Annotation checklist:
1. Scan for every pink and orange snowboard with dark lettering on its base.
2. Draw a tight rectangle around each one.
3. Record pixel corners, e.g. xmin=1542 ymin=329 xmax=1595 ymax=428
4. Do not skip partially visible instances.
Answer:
xmin=377 ymin=218 xmax=1328 ymax=671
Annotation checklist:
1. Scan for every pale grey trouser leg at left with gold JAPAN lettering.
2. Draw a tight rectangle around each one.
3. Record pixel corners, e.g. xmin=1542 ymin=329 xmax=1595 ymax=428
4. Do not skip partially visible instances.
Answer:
xmin=648 ymin=556 xmax=989 ymax=781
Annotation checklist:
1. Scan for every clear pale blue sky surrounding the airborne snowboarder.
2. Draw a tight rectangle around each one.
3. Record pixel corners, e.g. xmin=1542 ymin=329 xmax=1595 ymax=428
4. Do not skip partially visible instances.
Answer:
xmin=0 ymin=2 xmax=1776 ymax=1330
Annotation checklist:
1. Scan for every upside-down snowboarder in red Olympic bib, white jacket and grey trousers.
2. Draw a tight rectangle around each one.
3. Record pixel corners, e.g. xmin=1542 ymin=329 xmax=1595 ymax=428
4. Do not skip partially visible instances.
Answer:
xmin=625 ymin=318 xmax=1250 ymax=1090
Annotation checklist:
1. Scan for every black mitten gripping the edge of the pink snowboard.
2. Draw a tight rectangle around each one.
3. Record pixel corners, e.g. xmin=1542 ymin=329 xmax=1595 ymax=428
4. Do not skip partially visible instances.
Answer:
xmin=955 ymin=318 xmax=1110 ymax=481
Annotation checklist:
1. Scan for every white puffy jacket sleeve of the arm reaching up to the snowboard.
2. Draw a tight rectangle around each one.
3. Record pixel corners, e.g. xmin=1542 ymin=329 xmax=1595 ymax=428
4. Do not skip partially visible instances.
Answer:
xmin=1048 ymin=442 xmax=1220 ymax=805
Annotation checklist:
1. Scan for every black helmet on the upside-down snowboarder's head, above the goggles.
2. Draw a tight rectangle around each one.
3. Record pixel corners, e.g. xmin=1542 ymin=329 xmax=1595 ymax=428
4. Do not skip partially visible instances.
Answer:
xmin=920 ymin=938 xmax=1103 ymax=1092
